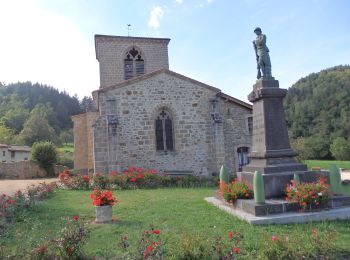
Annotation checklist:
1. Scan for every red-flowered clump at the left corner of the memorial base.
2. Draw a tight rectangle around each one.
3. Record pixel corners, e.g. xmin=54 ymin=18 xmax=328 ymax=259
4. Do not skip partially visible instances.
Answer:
xmin=222 ymin=178 xmax=253 ymax=203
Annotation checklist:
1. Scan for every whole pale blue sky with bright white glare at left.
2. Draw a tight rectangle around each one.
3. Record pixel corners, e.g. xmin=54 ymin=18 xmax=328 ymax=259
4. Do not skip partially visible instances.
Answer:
xmin=0 ymin=0 xmax=350 ymax=101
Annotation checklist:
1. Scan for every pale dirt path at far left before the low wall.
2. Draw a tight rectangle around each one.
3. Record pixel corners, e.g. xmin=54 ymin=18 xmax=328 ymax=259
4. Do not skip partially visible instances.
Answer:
xmin=0 ymin=178 xmax=58 ymax=195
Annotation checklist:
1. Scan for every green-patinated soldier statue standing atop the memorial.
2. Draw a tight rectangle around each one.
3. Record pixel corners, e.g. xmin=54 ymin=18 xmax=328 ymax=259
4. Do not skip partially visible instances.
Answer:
xmin=253 ymin=27 xmax=272 ymax=79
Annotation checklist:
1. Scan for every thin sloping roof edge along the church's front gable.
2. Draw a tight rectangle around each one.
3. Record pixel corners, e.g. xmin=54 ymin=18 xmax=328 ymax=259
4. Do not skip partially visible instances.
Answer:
xmin=92 ymin=69 xmax=252 ymax=109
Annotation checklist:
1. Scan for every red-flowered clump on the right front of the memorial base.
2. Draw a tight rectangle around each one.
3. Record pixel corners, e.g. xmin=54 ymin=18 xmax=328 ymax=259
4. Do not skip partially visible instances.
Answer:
xmin=285 ymin=177 xmax=331 ymax=210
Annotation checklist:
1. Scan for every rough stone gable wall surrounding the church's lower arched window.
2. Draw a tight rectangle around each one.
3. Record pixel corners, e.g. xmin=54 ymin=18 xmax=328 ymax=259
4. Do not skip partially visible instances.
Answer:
xmin=95 ymin=73 xmax=218 ymax=175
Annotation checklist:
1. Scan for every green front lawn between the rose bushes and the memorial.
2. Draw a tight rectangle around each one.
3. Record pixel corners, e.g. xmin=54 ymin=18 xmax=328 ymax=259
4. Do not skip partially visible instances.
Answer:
xmin=2 ymin=188 xmax=350 ymax=259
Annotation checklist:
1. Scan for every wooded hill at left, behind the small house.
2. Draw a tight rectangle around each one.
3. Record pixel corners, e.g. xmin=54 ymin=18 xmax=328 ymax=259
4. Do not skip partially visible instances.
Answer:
xmin=0 ymin=82 xmax=83 ymax=145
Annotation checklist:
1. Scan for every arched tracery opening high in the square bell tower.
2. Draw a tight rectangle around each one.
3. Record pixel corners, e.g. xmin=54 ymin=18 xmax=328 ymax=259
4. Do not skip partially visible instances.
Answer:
xmin=124 ymin=47 xmax=145 ymax=80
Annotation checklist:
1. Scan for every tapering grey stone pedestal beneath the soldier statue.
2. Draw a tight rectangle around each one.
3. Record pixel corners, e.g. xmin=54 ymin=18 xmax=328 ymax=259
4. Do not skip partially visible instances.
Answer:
xmin=240 ymin=78 xmax=308 ymax=198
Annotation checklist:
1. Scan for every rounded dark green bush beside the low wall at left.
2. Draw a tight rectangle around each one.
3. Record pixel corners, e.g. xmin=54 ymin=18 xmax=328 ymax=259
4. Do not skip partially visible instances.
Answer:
xmin=32 ymin=141 xmax=57 ymax=174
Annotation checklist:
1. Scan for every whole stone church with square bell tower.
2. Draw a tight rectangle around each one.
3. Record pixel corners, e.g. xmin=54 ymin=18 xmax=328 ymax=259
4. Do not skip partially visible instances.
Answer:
xmin=72 ymin=35 xmax=252 ymax=176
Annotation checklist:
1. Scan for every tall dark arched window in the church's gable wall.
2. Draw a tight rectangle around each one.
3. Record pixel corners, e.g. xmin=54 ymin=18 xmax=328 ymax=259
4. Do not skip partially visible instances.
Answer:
xmin=155 ymin=110 xmax=174 ymax=151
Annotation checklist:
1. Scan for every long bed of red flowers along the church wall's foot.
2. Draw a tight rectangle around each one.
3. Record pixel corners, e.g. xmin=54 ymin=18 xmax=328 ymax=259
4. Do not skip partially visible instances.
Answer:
xmin=59 ymin=167 xmax=217 ymax=190
